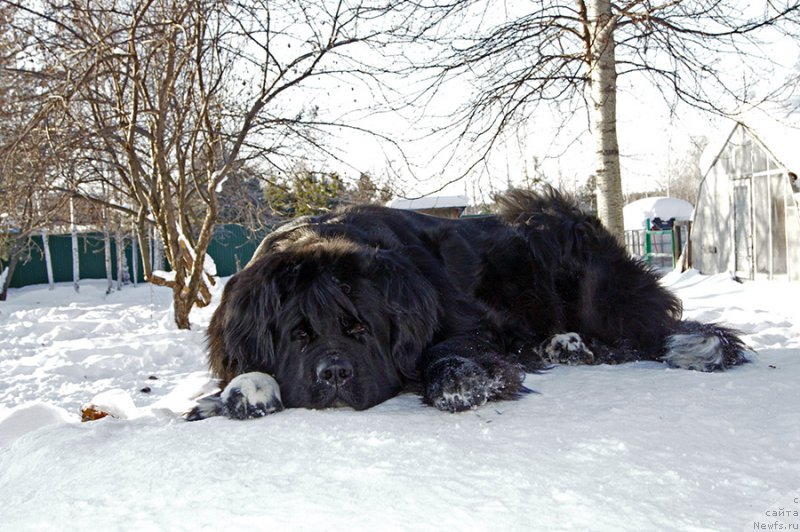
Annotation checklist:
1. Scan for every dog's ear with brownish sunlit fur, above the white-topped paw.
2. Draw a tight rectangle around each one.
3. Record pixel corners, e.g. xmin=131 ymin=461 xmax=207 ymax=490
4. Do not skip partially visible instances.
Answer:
xmin=208 ymin=259 xmax=280 ymax=385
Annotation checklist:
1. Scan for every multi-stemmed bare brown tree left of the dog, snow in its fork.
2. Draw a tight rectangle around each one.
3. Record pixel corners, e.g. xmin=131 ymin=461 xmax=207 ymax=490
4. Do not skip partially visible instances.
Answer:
xmin=14 ymin=0 xmax=406 ymax=328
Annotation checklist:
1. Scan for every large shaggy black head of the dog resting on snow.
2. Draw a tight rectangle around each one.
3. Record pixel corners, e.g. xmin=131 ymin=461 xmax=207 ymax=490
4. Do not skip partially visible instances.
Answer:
xmin=208 ymin=235 xmax=440 ymax=410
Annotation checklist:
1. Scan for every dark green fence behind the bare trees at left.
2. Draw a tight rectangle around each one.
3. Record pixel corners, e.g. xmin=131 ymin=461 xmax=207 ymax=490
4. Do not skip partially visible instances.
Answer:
xmin=0 ymin=224 xmax=262 ymax=288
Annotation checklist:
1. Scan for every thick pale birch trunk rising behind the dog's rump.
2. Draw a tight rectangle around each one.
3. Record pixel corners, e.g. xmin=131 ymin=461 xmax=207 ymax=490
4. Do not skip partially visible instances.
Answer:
xmin=587 ymin=0 xmax=625 ymax=242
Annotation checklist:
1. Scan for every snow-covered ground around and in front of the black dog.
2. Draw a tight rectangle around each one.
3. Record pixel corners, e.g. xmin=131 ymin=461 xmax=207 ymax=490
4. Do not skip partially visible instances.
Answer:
xmin=0 ymin=272 xmax=800 ymax=531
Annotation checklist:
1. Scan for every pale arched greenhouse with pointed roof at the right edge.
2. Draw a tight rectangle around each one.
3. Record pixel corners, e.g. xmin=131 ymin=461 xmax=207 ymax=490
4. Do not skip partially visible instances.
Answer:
xmin=691 ymin=109 xmax=800 ymax=281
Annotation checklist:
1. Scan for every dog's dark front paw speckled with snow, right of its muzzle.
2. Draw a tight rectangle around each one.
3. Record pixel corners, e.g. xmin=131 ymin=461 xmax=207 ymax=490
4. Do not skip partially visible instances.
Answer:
xmin=423 ymin=356 xmax=491 ymax=412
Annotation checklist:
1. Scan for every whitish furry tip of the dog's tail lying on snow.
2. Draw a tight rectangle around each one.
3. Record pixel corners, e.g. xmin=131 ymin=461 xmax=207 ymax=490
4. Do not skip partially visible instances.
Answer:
xmin=662 ymin=321 xmax=752 ymax=371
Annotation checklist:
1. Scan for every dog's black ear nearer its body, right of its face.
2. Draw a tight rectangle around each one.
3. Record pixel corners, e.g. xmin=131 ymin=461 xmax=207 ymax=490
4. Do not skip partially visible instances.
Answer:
xmin=366 ymin=248 xmax=442 ymax=380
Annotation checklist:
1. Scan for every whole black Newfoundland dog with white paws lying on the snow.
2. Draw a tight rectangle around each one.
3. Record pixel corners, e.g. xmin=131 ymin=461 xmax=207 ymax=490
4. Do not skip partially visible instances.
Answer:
xmin=187 ymin=189 xmax=747 ymax=420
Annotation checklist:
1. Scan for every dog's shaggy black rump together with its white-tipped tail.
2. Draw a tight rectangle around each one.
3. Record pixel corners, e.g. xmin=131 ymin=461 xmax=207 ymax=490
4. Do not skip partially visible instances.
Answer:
xmin=497 ymin=188 xmax=746 ymax=371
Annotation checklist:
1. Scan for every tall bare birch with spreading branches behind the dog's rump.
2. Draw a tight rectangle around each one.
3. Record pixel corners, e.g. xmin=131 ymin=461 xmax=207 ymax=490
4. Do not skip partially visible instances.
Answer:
xmin=398 ymin=0 xmax=800 ymax=240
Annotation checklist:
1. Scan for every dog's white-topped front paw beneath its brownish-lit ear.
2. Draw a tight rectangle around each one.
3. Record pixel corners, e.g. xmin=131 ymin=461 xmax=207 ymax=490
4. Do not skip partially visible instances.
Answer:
xmin=219 ymin=371 xmax=283 ymax=419
